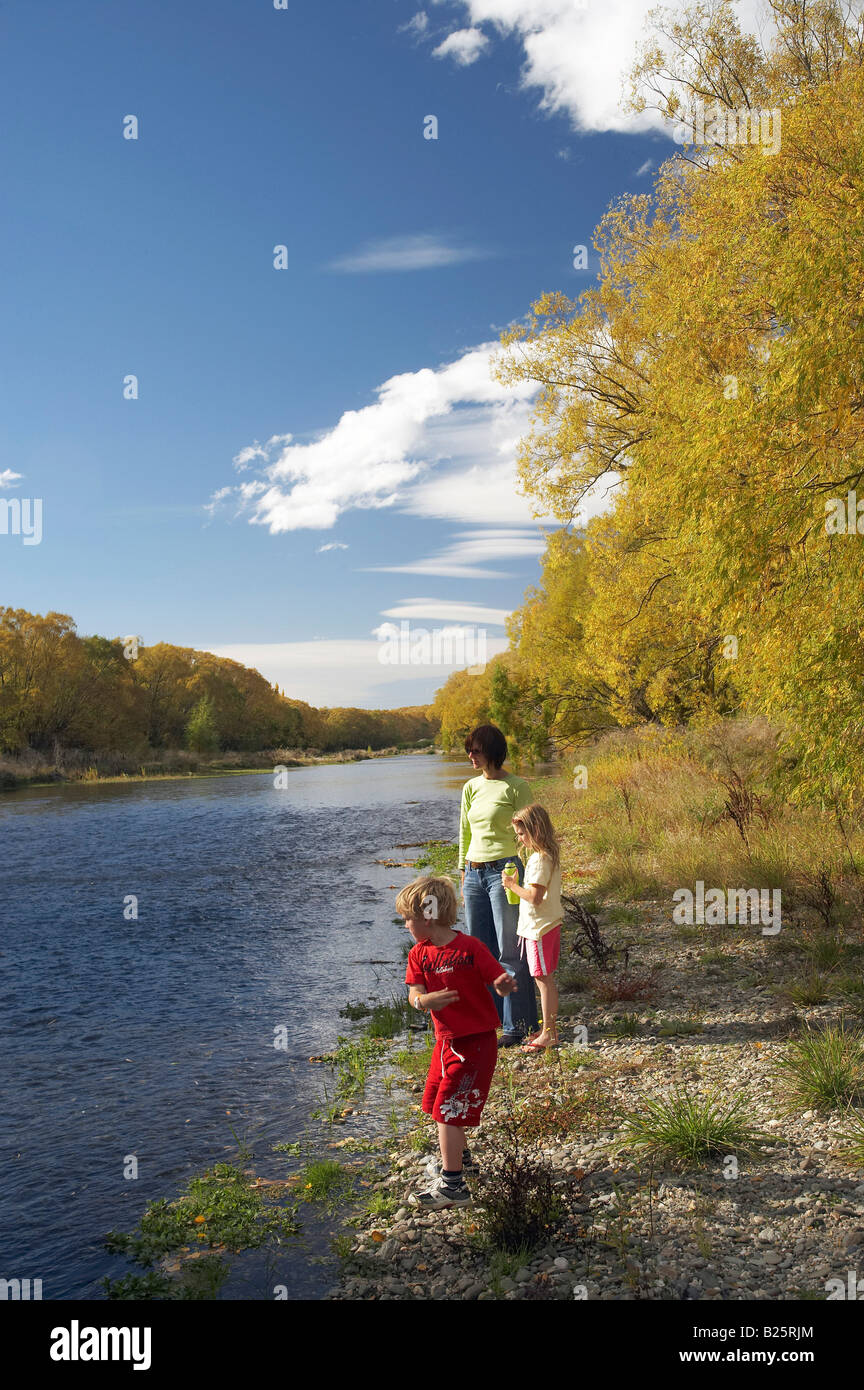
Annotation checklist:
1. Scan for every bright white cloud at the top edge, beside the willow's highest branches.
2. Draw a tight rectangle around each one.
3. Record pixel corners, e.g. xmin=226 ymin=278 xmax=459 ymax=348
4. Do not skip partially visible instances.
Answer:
xmin=419 ymin=0 xmax=771 ymax=135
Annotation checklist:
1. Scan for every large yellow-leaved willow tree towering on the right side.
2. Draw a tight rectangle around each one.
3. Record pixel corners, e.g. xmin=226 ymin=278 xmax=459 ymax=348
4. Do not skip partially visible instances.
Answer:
xmin=497 ymin=0 xmax=864 ymax=801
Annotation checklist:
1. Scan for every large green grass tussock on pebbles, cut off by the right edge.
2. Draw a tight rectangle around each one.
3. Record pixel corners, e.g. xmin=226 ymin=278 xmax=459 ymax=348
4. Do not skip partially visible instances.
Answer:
xmin=776 ymin=1020 xmax=864 ymax=1111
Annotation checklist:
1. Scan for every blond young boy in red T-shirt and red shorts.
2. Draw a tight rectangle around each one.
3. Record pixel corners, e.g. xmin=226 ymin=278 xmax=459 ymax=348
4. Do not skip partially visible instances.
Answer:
xmin=396 ymin=877 xmax=517 ymax=1209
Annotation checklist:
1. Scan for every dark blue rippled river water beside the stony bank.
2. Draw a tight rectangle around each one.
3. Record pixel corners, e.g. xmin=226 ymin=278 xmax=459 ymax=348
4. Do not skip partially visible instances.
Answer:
xmin=0 ymin=756 xmax=465 ymax=1298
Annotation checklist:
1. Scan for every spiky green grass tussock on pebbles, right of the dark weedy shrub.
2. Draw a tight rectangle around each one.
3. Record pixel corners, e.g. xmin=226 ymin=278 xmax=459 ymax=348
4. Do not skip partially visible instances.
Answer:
xmin=618 ymin=1088 xmax=771 ymax=1168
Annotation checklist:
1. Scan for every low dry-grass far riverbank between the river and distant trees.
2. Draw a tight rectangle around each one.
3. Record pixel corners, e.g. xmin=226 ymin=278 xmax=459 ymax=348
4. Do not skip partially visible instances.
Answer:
xmin=0 ymin=746 xmax=436 ymax=792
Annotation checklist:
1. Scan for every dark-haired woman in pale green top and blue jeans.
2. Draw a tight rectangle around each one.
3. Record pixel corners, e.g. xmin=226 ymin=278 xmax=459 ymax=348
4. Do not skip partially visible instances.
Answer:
xmin=458 ymin=724 xmax=539 ymax=1047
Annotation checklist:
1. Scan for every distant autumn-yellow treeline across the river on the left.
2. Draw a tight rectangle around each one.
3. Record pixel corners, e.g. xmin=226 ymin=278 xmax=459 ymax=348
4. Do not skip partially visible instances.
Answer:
xmin=0 ymin=607 xmax=438 ymax=756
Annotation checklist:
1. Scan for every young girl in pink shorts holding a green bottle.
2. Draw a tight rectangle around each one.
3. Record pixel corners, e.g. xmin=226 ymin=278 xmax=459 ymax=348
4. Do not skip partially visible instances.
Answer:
xmin=501 ymin=805 xmax=564 ymax=1052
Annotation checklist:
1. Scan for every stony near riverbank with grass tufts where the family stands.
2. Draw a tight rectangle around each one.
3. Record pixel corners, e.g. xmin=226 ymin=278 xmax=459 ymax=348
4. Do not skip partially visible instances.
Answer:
xmin=322 ymin=759 xmax=864 ymax=1301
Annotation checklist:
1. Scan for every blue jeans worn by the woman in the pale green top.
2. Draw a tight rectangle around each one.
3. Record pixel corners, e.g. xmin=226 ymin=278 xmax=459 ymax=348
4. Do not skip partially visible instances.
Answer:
xmin=463 ymin=855 xmax=539 ymax=1033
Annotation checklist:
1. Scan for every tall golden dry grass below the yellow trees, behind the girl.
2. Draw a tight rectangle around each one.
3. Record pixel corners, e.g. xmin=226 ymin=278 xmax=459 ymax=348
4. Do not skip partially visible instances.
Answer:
xmin=545 ymin=720 xmax=864 ymax=929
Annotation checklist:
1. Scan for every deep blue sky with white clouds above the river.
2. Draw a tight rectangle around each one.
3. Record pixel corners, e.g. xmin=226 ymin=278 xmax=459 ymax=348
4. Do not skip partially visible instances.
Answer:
xmin=0 ymin=0 xmax=766 ymax=706
